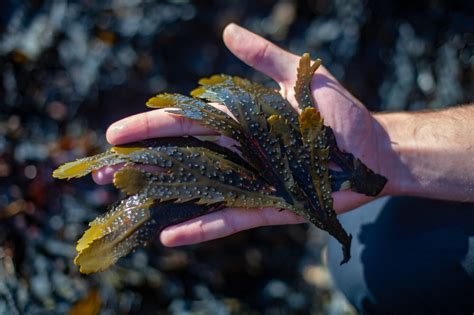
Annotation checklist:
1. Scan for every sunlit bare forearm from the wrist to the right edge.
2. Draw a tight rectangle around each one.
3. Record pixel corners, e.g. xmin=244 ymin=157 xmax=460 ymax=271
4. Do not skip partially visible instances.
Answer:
xmin=375 ymin=105 xmax=474 ymax=202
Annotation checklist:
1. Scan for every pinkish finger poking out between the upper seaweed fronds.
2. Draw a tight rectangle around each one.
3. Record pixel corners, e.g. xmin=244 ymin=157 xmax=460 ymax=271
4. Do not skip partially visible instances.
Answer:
xmin=106 ymin=109 xmax=216 ymax=145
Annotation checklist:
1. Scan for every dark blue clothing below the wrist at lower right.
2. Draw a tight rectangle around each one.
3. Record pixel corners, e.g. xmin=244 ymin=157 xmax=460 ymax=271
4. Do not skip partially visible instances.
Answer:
xmin=329 ymin=197 xmax=474 ymax=315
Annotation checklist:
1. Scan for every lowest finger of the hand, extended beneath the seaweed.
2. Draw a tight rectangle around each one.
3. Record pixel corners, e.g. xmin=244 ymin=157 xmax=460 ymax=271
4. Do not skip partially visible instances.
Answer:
xmin=160 ymin=208 xmax=306 ymax=246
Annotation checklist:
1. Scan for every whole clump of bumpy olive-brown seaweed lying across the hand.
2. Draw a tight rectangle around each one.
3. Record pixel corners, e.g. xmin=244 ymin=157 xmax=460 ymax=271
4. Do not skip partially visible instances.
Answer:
xmin=53 ymin=54 xmax=386 ymax=273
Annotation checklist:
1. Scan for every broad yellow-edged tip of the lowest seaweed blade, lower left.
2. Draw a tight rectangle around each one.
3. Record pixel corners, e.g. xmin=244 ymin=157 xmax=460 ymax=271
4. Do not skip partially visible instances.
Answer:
xmin=74 ymin=199 xmax=153 ymax=274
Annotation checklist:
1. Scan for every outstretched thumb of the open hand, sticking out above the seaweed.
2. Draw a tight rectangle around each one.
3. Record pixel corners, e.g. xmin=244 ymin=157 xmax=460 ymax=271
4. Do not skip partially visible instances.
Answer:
xmin=223 ymin=23 xmax=299 ymax=86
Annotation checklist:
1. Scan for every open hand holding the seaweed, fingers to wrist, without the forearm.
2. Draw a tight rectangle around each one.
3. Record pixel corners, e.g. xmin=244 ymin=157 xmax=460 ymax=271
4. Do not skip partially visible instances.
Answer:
xmin=90 ymin=24 xmax=391 ymax=246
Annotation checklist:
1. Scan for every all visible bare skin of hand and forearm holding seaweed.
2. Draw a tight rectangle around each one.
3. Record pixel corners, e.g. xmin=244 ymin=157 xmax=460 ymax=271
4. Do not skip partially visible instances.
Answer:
xmin=93 ymin=24 xmax=474 ymax=246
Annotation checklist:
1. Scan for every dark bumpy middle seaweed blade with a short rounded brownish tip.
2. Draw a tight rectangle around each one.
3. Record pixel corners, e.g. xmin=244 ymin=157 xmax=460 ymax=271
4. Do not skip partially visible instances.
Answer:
xmin=114 ymin=143 xmax=292 ymax=212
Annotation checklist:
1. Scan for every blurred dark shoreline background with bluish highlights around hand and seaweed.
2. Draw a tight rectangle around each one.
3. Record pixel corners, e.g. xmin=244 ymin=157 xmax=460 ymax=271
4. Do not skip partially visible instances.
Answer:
xmin=0 ymin=0 xmax=474 ymax=314
